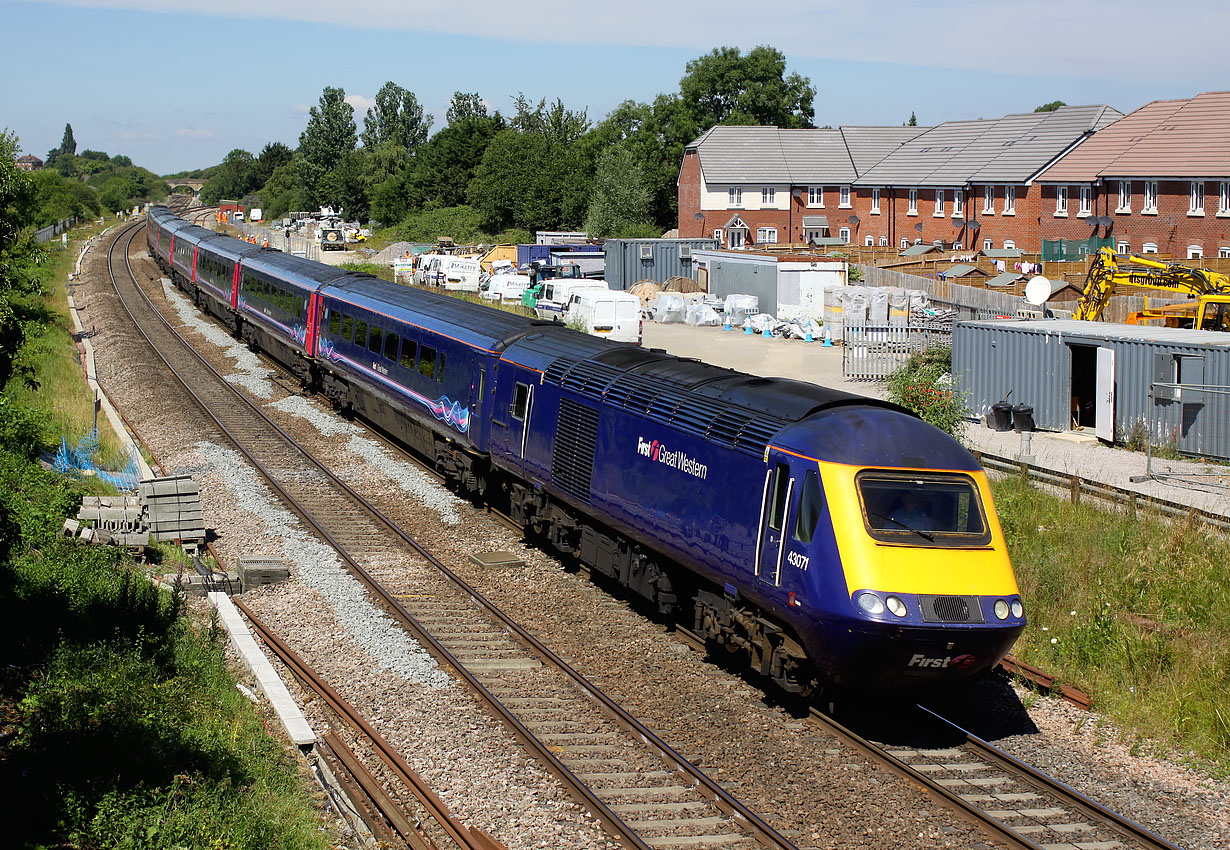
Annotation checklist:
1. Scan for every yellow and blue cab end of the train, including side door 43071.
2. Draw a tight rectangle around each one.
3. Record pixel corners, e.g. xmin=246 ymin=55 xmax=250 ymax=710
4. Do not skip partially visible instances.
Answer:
xmin=718 ymin=402 xmax=1026 ymax=690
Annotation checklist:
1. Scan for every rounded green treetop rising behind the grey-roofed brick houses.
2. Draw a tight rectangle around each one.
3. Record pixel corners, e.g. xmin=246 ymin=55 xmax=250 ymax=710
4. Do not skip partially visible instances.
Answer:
xmin=679 ymin=46 xmax=815 ymax=129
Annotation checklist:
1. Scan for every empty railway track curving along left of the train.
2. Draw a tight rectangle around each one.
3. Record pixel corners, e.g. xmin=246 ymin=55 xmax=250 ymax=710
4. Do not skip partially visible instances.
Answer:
xmin=108 ymin=221 xmax=811 ymax=850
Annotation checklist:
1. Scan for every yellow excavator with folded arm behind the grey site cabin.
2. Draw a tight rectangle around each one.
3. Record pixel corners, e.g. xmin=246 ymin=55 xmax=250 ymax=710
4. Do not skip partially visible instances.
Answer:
xmin=1074 ymin=248 xmax=1230 ymax=331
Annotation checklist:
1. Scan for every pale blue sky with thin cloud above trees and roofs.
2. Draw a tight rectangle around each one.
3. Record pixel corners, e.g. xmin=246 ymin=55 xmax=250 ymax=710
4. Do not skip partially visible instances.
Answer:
xmin=0 ymin=0 xmax=1230 ymax=175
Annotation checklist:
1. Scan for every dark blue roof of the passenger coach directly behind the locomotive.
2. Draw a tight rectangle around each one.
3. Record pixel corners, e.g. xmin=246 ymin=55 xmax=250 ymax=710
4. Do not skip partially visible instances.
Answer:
xmin=321 ymin=276 xmax=535 ymax=352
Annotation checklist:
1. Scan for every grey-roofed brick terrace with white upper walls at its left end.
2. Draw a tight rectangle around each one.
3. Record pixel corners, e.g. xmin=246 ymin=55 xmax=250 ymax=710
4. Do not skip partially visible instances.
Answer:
xmin=679 ymin=106 xmax=1122 ymax=251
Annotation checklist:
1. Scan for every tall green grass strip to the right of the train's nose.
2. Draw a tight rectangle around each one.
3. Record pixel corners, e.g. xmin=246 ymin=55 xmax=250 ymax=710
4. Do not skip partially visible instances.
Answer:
xmin=994 ymin=477 xmax=1230 ymax=775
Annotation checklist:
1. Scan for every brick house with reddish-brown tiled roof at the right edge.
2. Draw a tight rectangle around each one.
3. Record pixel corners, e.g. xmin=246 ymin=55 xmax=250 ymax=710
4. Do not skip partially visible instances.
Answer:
xmin=1038 ymin=91 xmax=1230 ymax=260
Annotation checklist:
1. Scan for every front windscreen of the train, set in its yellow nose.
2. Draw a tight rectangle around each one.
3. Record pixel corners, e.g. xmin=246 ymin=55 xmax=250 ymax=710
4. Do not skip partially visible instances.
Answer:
xmin=855 ymin=471 xmax=990 ymax=545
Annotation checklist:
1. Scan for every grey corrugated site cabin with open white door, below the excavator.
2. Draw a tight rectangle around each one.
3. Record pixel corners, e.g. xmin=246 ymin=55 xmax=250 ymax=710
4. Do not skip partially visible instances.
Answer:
xmin=952 ymin=320 xmax=1230 ymax=459
